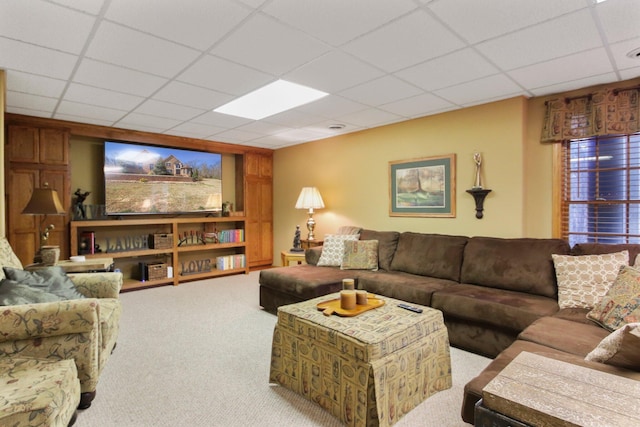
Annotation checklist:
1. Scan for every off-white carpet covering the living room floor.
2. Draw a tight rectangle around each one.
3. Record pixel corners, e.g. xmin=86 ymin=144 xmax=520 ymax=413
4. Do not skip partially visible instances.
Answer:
xmin=76 ymin=272 xmax=490 ymax=427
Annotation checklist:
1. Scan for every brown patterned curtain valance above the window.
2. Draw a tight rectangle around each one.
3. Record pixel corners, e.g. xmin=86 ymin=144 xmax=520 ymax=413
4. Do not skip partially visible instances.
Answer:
xmin=542 ymin=87 xmax=640 ymax=142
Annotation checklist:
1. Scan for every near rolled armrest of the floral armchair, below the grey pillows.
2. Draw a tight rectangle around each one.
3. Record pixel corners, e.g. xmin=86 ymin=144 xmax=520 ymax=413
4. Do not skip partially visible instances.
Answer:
xmin=0 ymin=298 xmax=100 ymax=343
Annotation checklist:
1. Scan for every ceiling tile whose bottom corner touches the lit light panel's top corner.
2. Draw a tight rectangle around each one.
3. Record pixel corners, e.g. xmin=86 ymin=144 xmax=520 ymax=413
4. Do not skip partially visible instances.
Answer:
xmin=211 ymin=15 xmax=329 ymax=75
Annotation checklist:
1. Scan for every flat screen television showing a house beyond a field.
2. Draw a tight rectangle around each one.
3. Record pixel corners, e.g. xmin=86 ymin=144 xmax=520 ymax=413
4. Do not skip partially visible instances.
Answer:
xmin=104 ymin=141 xmax=222 ymax=215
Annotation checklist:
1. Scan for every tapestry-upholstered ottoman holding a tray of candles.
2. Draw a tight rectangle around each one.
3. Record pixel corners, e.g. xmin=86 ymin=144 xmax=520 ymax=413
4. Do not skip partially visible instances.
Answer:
xmin=269 ymin=293 xmax=451 ymax=426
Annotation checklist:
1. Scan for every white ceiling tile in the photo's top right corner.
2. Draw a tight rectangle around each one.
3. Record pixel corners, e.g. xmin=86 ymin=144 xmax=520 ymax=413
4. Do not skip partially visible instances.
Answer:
xmin=596 ymin=0 xmax=640 ymax=43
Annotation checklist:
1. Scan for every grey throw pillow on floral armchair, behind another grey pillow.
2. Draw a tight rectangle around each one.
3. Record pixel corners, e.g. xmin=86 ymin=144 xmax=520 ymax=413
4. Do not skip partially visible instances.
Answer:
xmin=4 ymin=267 xmax=84 ymax=299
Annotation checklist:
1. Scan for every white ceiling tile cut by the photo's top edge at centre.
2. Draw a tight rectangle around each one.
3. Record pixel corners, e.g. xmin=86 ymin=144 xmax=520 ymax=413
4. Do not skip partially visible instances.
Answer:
xmin=263 ymin=0 xmax=416 ymax=46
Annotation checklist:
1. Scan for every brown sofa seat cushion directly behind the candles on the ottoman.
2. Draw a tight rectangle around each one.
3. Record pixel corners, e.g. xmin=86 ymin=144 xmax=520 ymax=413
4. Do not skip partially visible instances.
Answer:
xmin=358 ymin=271 xmax=456 ymax=306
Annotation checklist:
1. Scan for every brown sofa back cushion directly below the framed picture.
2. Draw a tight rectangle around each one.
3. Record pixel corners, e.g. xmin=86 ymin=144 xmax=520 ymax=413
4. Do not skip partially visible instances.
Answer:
xmin=391 ymin=232 xmax=467 ymax=282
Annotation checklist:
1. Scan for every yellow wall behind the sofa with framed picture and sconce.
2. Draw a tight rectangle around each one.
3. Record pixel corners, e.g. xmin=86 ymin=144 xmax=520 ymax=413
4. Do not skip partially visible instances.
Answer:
xmin=274 ymin=97 xmax=527 ymax=263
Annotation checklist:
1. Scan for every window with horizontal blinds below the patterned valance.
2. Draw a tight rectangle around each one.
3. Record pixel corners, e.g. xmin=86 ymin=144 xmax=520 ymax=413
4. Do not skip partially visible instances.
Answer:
xmin=561 ymin=133 xmax=640 ymax=246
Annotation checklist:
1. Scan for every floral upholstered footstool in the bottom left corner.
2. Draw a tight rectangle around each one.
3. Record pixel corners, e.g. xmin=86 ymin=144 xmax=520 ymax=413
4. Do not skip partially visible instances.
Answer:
xmin=0 ymin=357 xmax=80 ymax=427
